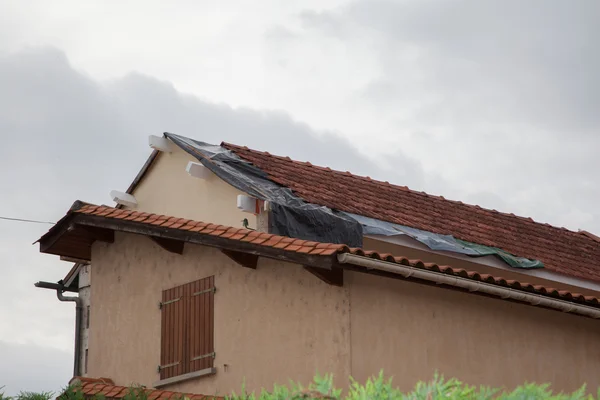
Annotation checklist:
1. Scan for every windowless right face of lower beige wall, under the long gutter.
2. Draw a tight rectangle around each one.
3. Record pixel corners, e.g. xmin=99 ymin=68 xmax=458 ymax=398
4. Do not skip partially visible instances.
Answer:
xmin=348 ymin=274 xmax=600 ymax=391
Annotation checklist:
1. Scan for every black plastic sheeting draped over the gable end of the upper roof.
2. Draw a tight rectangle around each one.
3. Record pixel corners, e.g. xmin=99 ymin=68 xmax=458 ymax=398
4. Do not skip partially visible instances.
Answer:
xmin=165 ymin=133 xmax=363 ymax=247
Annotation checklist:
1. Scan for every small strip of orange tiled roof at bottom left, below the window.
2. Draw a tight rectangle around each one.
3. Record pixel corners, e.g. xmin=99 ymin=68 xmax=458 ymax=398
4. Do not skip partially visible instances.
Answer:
xmin=65 ymin=377 xmax=223 ymax=400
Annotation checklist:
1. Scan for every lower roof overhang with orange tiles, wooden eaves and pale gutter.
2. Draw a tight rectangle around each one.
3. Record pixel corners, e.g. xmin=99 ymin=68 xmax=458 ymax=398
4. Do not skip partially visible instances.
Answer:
xmin=39 ymin=202 xmax=600 ymax=318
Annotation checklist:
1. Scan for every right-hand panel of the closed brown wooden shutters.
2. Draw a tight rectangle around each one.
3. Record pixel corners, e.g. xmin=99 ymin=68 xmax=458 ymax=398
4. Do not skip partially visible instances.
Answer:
xmin=189 ymin=276 xmax=215 ymax=372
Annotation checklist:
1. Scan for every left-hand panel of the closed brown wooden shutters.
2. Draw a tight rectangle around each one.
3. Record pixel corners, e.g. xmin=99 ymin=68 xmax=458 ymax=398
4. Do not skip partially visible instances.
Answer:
xmin=159 ymin=285 xmax=189 ymax=379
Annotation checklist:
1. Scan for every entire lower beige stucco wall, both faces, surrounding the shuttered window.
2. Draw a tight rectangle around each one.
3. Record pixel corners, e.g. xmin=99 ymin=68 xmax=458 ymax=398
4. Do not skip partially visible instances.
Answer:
xmin=89 ymin=233 xmax=600 ymax=394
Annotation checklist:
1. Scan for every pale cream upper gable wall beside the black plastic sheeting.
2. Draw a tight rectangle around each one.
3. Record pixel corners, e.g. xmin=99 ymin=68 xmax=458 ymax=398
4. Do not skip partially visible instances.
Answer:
xmin=126 ymin=146 xmax=256 ymax=228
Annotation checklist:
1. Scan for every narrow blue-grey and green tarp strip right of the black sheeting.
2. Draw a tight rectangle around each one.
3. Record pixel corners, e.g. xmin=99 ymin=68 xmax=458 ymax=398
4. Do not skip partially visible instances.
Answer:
xmin=345 ymin=213 xmax=544 ymax=269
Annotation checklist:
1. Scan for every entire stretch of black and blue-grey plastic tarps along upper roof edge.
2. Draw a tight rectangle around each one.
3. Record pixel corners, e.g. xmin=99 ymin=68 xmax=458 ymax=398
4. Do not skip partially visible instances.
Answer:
xmin=165 ymin=133 xmax=544 ymax=269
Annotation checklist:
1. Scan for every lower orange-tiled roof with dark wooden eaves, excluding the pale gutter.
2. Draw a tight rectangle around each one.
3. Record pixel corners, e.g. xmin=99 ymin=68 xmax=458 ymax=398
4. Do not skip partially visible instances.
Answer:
xmin=39 ymin=201 xmax=600 ymax=318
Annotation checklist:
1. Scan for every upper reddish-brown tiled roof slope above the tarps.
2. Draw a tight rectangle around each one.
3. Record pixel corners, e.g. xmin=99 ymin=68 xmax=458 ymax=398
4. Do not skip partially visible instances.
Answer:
xmin=221 ymin=143 xmax=600 ymax=281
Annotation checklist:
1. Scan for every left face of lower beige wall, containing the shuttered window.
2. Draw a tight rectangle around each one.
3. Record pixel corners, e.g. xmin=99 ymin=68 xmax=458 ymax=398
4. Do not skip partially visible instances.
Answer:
xmin=89 ymin=234 xmax=350 ymax=394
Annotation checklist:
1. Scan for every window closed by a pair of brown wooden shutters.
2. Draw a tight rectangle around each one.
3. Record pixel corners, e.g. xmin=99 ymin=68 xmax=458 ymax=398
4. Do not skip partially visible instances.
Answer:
xmin=158 ymin=276 xmax=215 ymax=380
